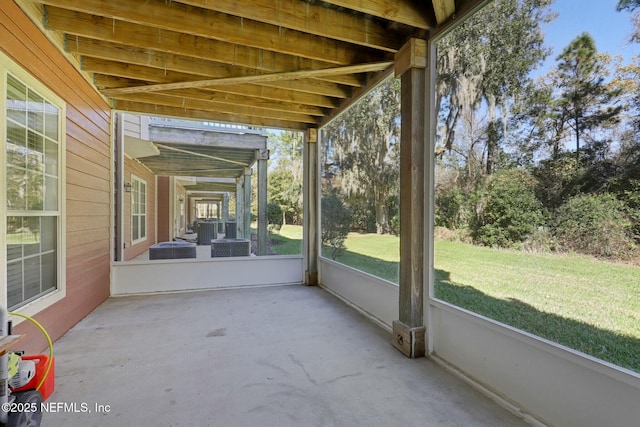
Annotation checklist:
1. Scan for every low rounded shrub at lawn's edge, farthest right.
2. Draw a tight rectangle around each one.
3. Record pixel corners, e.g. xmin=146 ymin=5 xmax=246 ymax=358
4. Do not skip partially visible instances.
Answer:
xmin=553 ymin=194 xmax=635 ymax=259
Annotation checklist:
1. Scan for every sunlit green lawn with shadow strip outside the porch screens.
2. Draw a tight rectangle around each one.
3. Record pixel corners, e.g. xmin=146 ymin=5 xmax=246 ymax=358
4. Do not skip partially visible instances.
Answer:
xmin=287 ymin=227 xmax=640 ymax=372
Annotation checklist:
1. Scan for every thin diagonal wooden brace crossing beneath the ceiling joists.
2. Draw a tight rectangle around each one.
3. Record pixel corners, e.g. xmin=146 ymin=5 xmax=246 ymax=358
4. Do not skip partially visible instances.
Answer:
xmin=103 ymin=62 xmax=393 ymax=95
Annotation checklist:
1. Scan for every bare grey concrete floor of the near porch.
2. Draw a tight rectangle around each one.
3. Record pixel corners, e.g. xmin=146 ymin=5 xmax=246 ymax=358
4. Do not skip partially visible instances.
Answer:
xmin=42 ymin=286 xmax=527 ymax=427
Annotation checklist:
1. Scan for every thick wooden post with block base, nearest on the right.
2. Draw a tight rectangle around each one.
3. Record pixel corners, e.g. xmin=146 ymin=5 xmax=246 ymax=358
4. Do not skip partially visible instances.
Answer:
xmin=393 ymin=39 xmax=427 ymax=358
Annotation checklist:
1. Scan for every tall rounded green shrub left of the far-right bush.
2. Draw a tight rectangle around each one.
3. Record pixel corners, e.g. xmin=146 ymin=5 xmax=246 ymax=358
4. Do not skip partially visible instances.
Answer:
xmin=471 ymin=169 xmax=543 ymax=248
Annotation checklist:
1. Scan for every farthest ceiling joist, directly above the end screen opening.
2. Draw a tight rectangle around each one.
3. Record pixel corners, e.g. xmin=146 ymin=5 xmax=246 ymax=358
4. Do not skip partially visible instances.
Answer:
xmin=113 ymin=100 xmax=309 ymax=130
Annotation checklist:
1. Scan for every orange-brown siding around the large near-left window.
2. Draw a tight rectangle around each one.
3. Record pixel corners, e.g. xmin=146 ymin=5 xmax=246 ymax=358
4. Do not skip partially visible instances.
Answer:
xmin=0 ymin=0 xmax=111 ymax=353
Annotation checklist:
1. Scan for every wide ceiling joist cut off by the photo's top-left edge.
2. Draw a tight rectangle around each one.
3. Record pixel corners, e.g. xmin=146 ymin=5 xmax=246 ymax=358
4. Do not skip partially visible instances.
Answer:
xmin=38 ymin=0 xmax=380 ymax=65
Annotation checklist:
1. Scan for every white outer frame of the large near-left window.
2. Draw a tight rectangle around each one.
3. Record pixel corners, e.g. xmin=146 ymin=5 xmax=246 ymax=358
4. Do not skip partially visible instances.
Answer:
xmin=0 ymin=52 xmax=67 ymax=318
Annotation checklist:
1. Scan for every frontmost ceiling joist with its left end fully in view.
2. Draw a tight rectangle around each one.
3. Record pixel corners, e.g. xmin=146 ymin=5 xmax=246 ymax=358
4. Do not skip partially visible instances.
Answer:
xmin=44 ymin=6 xmax=364 ymax=87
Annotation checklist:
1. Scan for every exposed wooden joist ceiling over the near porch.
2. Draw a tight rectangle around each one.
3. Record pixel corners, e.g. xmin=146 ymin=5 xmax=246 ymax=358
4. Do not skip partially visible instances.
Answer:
xmin=16 ymin=0 xmax=468 ymax=130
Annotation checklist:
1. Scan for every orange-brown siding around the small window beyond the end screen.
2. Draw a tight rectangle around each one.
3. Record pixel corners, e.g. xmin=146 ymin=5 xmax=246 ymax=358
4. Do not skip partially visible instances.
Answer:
xmin=123 ymin=158 xmax=156 ymax=261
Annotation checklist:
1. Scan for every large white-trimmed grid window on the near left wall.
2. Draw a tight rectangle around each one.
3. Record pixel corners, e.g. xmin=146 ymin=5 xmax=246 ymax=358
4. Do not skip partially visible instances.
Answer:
xmin=0 ymin=56 xmax=66 ymax=310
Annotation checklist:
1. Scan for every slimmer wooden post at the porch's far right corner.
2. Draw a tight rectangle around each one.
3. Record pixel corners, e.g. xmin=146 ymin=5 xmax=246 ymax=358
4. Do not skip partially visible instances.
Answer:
xmin=303 ymin=128 xmax=320 ymax=286
